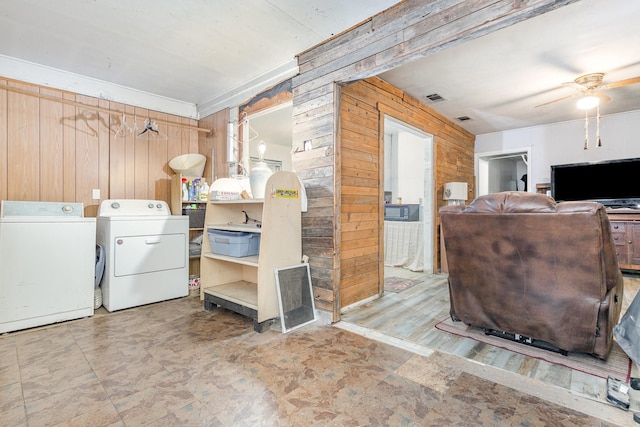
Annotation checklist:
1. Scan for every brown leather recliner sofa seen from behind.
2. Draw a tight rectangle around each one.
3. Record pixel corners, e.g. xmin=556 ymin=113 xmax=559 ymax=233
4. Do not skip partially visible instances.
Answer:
xmin=439 ymin=191 xmax=623 ymax=359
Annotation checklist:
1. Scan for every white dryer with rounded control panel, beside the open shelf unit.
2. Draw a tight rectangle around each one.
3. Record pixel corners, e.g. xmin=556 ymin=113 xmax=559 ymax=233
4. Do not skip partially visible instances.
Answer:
xmin=96 ymin=199 xmax=189 ymax=311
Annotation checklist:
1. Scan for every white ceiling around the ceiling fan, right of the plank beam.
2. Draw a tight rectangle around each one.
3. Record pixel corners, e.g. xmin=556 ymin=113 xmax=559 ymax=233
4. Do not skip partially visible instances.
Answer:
xmin=380 ymin=0 xmax=640 ymax=135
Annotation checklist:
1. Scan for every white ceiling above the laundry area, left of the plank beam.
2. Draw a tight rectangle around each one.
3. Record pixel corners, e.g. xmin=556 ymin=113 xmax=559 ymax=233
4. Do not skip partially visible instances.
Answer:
xmin=0 ymin=0 xmax=398 ymax=116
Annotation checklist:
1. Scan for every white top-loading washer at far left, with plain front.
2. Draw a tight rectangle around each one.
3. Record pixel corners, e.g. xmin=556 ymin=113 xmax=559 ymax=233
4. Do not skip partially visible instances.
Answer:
xmin=0 ymin=200 xmax=96 ymax=333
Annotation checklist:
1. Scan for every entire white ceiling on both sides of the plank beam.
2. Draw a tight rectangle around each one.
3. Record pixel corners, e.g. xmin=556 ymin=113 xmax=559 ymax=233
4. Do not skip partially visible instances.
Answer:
xmin=0 ymin=0 xmax=640 ymax=134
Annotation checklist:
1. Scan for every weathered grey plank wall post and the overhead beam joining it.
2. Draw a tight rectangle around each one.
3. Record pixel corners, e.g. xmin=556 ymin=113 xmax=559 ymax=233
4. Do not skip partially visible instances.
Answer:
xmin=292 ymin=0 xmax=578 ymax=321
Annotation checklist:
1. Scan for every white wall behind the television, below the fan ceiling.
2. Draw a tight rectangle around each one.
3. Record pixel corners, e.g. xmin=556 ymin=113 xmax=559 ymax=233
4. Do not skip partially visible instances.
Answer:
xmin=475 ymin=110 xmax=640 ymax=187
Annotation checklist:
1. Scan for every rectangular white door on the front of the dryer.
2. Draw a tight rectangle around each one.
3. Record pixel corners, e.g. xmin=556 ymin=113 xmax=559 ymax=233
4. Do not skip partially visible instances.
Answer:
xmin=113 ymin=234 xmax=187 ymax=277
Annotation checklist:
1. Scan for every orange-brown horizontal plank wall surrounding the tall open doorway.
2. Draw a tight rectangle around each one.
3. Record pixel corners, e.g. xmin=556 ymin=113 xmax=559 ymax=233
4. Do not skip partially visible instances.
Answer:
xmin=339 ymin=78 xmax=475 ymax=307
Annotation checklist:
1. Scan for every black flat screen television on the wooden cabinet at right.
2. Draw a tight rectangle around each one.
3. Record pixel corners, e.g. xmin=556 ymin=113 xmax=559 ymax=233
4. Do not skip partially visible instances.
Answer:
xmin=551 ymin=158 xmax=640 ymax=209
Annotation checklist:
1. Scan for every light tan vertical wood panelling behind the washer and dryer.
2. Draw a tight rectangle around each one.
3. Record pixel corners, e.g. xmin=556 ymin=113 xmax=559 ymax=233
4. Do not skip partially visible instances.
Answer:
xmin=0 ymin=78 xmax=228 ymax=216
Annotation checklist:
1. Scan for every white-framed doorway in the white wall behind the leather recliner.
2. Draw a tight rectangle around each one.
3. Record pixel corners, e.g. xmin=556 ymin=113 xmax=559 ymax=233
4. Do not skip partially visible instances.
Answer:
xmin=476 ymin=148 xmax=531 ymax=196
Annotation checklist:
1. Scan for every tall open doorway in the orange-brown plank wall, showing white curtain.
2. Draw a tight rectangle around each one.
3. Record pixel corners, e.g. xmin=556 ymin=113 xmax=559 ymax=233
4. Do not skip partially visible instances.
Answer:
xmin=382 ymin=115 xmax=434 ymax=282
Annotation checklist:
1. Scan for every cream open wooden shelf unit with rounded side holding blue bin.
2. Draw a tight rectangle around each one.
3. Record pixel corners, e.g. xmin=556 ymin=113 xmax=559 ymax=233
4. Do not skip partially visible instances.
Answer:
xmin=200 ymin=172 xmax=302 ymax=332
